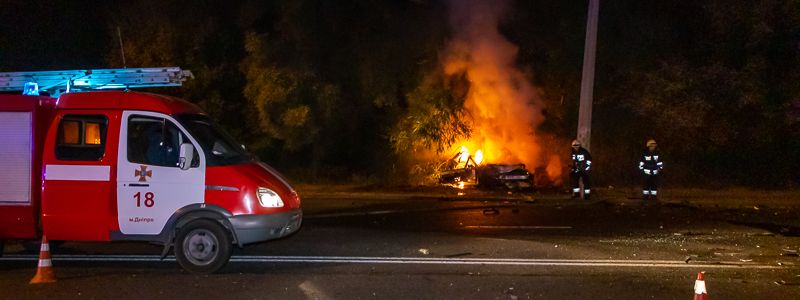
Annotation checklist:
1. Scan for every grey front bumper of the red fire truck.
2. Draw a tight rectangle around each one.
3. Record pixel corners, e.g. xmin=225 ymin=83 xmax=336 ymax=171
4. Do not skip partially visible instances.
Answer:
xmin=228 ymin=208 xmax=303 ymax=246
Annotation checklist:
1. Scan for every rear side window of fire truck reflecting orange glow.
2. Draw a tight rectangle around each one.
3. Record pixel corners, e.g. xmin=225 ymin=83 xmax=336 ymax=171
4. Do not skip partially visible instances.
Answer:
xmin=56 ymin=115 xmax=108 ymax=161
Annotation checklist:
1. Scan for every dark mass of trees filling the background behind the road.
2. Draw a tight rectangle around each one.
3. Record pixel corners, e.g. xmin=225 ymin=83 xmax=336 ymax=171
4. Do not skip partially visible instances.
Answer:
xmin=0 ymin=0 xmax=800 ymax=186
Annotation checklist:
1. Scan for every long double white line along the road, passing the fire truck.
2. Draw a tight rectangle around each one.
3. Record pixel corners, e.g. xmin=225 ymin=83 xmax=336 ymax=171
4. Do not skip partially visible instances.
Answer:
xmin=0 ymin=255 xmax=795 ymax=269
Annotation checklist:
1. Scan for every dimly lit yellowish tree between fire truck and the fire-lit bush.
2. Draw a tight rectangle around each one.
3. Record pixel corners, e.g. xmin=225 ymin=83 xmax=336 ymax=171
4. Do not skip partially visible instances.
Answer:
xmin=236 ymin=32 xmax=340 ymax=177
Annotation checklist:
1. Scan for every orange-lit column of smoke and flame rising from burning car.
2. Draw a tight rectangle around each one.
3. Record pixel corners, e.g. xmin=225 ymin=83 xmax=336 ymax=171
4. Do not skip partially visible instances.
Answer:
xmin=443 ymin=0 xmax=561 ymax=181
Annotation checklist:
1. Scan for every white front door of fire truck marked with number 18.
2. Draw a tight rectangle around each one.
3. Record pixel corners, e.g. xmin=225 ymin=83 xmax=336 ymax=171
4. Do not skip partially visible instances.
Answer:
xmin=117 ymin=111 xmax=205 ymax=235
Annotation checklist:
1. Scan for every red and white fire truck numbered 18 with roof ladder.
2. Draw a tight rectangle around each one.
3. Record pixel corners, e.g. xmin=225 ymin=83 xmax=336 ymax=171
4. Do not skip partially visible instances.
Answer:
xmin=0 ymin=67 xmax=303 ymax=273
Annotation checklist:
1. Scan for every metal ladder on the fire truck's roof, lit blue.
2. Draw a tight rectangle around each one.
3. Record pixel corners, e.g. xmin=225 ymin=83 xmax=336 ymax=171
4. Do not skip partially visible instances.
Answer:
xmin=0 ymin=67 xmax=194 ymax=97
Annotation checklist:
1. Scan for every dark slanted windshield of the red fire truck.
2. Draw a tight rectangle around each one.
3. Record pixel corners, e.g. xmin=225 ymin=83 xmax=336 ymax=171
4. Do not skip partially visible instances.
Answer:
xmin=176 ymin=115 xmax=253 ymax=166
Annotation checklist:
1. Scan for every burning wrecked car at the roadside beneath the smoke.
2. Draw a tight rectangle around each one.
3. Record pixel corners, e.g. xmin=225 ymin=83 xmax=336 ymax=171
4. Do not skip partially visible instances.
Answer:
xmin=439 ymin=147 xmax=533 ymax=190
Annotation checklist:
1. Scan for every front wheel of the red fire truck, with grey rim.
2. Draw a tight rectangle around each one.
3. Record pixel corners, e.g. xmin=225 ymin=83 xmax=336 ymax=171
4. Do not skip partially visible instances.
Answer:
xmin=175 ymin=219 xmax=233 ymax=274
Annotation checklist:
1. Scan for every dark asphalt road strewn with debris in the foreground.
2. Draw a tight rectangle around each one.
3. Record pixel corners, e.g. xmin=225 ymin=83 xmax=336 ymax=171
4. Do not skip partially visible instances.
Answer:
xmin=0 ymin=195 xmax=800 ymax=299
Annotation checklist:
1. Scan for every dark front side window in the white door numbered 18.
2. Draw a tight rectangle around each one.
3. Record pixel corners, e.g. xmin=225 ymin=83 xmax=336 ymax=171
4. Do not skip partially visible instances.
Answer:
xmin=128 ymin=116 xmax=197 ymax=167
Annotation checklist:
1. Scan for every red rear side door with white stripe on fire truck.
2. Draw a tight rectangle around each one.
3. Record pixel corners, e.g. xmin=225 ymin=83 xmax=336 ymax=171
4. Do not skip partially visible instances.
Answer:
xmin=41 ymin=111 xmax=118 ymax=241
